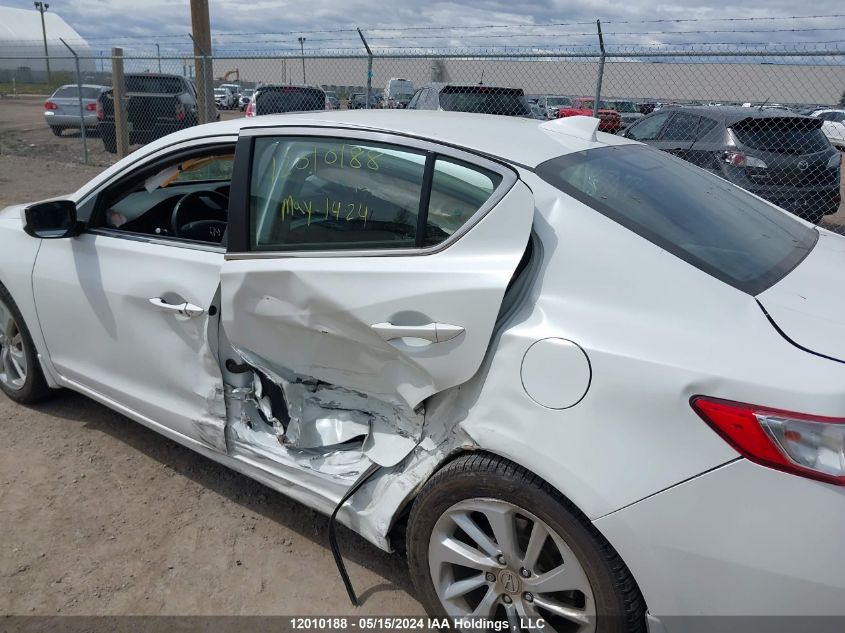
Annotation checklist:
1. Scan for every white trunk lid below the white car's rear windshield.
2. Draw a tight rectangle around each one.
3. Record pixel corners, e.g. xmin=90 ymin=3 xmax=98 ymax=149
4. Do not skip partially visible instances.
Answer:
xmin=757 ymin=231 xmax=845 ymax=363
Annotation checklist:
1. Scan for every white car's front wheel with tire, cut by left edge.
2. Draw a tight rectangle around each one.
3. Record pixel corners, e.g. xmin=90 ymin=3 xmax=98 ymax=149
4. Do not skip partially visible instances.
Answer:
xmin=0 ymin=284 xmax=53 ymax=404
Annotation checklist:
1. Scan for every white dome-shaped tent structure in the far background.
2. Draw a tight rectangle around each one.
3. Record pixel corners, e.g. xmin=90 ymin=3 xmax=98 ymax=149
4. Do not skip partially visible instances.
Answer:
xmin=0 ymin=6 xmax=95 ymax=75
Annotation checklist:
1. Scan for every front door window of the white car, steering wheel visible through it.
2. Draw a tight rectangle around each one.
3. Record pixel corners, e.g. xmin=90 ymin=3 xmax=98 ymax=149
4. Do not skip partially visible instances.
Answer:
xmin=96 ymin=147 xmax=234 ymax=243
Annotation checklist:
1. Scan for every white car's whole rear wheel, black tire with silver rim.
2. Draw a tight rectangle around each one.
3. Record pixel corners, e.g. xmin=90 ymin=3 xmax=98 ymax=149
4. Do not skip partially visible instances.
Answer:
xmin=406 ymin=453 xmax=646 ymax=633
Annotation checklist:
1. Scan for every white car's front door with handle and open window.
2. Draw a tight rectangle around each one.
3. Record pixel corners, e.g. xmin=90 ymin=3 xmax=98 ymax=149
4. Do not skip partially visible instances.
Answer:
xmin=33 ymin=141 xmax=235 ymax=450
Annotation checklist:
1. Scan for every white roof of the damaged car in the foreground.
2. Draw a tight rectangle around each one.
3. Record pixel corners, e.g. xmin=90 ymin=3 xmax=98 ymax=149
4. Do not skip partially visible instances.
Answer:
xmin=160 ymin=108 xmax=638 ymax=168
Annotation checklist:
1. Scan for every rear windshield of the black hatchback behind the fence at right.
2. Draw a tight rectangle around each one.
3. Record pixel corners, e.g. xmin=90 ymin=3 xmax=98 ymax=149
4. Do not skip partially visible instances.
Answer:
xmin=731 ymin=117 xmax=829 ymax=154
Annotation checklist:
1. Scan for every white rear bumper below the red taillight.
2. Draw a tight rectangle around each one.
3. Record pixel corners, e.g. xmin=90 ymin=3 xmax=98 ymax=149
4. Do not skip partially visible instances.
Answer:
xmin=595 ymin=459 xmax=845 ymax=633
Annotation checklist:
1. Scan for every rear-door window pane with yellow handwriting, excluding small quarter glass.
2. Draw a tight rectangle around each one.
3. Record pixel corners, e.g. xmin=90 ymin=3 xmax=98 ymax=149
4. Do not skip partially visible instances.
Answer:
xmin=250 ymin=138 xmax=425 ymax=251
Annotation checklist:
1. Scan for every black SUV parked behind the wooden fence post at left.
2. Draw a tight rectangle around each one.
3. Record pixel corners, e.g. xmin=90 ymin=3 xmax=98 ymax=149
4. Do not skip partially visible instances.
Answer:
xmin=97 ymin=73 xmax=206 ymax=154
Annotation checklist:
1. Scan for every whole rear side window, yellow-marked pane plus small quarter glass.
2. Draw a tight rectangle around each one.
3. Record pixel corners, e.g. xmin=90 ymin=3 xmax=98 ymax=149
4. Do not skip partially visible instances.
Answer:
xmin=249 ymin=137 xmax=503 ymax=251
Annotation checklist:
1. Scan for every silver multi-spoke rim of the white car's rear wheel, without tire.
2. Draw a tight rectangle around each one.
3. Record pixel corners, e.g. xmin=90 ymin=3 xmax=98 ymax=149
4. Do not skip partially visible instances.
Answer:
xmin=428 ymin=499 xmax=596 ymax=633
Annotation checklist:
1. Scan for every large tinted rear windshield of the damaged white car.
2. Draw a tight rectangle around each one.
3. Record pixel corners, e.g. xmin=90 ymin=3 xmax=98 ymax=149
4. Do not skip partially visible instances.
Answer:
xmin=537 ymin=145 xmax=818 ymax=295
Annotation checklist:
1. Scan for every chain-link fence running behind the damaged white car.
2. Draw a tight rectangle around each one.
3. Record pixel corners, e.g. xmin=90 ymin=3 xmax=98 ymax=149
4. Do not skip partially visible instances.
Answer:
xmin=0 ymin=42 xmax=845 ymax=234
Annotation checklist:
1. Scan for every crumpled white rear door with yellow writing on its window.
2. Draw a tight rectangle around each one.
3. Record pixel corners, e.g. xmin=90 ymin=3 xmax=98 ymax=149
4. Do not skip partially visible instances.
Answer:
xmin=221 ymin=128 xmax=534 ymax=454
